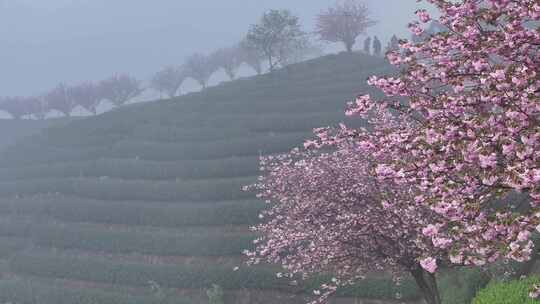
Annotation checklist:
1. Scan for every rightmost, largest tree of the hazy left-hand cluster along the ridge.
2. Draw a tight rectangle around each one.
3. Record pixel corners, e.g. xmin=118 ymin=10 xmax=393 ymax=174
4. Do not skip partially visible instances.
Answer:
xmin=99 ymin=74 xmax=144 ymax=107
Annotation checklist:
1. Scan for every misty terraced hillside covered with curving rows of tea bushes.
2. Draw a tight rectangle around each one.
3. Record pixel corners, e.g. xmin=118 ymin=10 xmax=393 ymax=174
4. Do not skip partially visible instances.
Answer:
xmin=0 ymin=54 xmax=418 ymax=304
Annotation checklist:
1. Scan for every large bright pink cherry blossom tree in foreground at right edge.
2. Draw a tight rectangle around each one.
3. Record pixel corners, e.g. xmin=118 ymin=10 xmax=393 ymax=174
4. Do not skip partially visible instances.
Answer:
xmin=342 ymin=0 xmax=540 ymax=265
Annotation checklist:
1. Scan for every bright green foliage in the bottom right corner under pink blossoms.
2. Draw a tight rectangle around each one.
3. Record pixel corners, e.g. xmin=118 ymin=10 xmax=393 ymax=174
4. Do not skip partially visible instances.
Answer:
xmin=472 ymin=276 xmax=540 ymax=304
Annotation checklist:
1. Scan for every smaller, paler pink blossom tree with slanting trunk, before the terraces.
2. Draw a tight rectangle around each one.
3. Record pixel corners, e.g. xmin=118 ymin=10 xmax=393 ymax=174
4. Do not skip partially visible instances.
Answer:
xmin=248 ymin=128 xmax=451 ymax=304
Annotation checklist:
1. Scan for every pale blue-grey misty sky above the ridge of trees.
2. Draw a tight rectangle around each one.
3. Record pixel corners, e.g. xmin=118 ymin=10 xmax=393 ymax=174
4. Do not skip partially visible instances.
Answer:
xmin=0 ymin=0 xmax=434 ymax=96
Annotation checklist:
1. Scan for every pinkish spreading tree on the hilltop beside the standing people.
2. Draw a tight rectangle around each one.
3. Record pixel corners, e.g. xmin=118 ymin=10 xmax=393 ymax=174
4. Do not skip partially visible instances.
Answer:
xmin=316 ymin=0 xmax=376 ymax=53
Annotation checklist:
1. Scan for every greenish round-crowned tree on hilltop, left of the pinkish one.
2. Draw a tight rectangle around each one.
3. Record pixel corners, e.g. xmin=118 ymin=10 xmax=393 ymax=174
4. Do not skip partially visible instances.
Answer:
xmin=246 ymin=10 xmax=308 ymax=71
